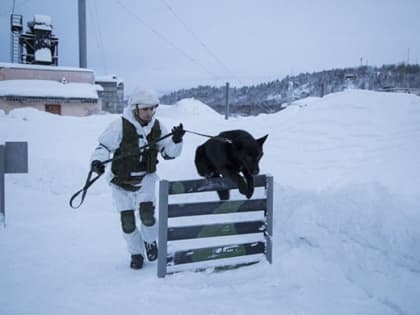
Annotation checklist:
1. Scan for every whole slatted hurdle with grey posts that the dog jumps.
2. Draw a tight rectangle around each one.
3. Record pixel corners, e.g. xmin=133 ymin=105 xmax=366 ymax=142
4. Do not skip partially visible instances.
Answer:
xmin=157 ymin=175 xmax=273 ymax=278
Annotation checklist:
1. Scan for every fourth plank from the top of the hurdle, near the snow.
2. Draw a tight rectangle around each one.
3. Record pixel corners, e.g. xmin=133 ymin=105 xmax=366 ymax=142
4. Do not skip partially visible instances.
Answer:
xmin=167 ymin=242 xmax=265 ymax=265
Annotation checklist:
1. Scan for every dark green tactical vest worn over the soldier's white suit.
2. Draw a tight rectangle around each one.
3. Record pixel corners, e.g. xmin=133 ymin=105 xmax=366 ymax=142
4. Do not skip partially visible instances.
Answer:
xmin=111 ymin=117 xmax=161 ymax=191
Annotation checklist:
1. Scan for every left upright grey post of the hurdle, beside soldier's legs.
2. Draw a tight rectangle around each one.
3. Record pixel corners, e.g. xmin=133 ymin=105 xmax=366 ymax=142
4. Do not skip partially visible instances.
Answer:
xmin=157 ymin=180 xmax=169 ymax=278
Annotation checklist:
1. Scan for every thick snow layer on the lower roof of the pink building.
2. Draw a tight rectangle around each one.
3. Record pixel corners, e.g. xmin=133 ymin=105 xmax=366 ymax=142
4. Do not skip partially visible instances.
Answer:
xmin=0 ymin=80 xmax=103 ymax=99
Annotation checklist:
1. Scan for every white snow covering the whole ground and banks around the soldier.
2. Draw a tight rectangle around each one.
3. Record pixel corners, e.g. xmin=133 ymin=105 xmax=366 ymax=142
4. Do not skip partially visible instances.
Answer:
xmin=0 ymin=90 xmax=420 ymax=315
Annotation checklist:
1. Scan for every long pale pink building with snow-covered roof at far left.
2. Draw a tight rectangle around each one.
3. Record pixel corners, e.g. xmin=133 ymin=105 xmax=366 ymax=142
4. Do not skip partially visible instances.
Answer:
xmin=0 ymin=63 xmax=103 ymax=116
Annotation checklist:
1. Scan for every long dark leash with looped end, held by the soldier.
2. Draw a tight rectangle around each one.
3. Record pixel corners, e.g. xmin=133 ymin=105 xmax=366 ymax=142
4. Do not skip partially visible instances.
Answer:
xmin=69 ymin=130 xmax=232 ymax=209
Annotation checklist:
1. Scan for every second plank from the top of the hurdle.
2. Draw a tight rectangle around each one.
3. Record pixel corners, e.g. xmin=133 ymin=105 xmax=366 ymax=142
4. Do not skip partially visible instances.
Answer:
xmin=168 ymin=199 xmax=267 ymax=218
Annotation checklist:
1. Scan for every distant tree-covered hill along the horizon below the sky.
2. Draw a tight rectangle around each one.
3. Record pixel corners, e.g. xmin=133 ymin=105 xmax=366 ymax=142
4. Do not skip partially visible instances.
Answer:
xmin=160 ymin=64 xmax=420 ymax=115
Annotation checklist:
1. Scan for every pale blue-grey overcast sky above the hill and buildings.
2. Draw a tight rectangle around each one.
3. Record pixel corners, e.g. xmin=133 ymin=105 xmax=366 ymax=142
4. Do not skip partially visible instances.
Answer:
xmin=0 ymin=0 xmax=420 ymax=93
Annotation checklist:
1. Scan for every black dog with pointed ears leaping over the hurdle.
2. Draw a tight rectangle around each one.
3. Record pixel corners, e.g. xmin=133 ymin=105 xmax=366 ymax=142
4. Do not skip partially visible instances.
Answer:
xmin=195 ymin=130 xmax=268 ymax=200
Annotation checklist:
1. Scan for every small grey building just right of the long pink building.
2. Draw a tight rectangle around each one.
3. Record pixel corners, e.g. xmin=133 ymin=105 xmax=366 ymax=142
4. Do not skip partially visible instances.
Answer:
xmin=95 ymin=75 xmax=124 ymax=113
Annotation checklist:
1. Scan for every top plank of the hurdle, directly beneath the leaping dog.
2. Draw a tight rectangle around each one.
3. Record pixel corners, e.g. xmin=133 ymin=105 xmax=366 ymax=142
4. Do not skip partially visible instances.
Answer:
xmin=169 ymin=175 xmax=266 ymax=195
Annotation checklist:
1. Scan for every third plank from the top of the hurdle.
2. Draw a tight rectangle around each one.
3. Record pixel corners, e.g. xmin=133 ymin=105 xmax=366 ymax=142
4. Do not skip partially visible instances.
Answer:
xmin=167 ymin=221 xmax=265 ymax=241
